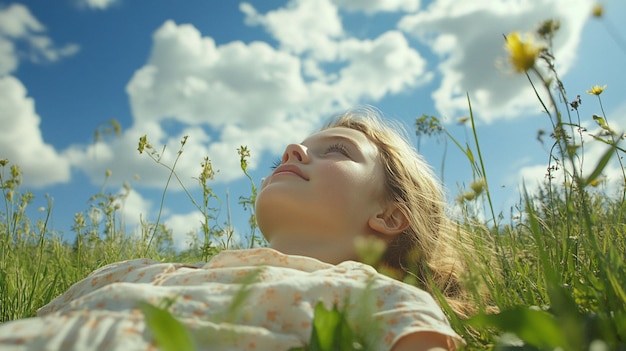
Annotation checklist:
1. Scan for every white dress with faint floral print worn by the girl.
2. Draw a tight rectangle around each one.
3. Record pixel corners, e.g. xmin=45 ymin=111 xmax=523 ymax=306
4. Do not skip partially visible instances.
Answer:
xmin=0 ymin=248 xmax=463 ymax=351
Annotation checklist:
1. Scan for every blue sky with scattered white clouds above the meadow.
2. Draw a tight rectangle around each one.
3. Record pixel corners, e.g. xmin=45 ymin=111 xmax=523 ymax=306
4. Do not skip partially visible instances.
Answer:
xmin=0 ymin=0 xmax=626 ymax=247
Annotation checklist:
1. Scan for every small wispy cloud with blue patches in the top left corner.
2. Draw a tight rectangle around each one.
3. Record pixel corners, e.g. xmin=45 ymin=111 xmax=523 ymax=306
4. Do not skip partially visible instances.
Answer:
xmin=0 ymin=4 xmax=79 ymax=75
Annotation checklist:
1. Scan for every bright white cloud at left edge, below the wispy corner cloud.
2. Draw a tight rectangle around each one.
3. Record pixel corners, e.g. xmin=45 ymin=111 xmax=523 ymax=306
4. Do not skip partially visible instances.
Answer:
xmin=0 ymin=76 xmax=70 ymax=187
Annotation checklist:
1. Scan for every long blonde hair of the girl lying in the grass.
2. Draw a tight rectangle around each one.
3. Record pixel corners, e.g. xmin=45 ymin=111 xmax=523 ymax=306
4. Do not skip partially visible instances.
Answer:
xmin=324 ymin=108 xmax=473 ymax=317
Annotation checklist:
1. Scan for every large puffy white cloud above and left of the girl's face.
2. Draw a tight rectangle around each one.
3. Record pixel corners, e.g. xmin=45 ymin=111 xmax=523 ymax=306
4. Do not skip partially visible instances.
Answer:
xmin=127 ymin=21 xmax=307 ymax=128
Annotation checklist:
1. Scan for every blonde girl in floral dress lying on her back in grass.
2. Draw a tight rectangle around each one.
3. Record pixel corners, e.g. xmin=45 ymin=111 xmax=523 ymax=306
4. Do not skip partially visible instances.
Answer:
xmin=0 ymin=109 xmax=466 ymax=351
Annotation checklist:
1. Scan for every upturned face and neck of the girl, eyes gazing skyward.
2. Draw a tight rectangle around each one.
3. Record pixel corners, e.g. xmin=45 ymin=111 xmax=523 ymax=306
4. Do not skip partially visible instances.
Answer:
xmin=256 ymin=127 xmax=384 ymax=263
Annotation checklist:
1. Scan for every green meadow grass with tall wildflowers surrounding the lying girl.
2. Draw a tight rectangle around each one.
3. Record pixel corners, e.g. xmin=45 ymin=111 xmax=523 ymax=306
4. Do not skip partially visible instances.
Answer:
xmin=0 ymin=13 xmax=626 ymax=351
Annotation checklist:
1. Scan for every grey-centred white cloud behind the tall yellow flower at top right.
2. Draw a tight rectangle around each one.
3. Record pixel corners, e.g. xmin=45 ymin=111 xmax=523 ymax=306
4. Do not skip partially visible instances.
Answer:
xmin=399 ymin=0 xmax=591 ymax=122
